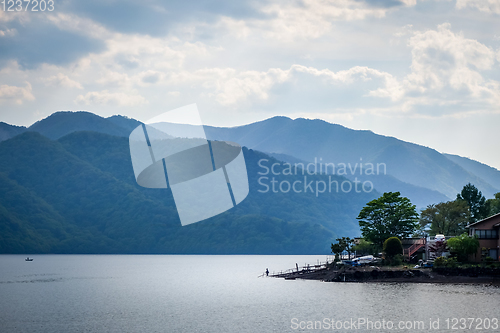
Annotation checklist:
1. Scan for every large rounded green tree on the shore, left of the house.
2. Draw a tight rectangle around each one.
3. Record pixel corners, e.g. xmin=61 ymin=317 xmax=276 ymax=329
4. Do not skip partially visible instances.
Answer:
xmin=357 ymin=192 xmax=418 ymax=248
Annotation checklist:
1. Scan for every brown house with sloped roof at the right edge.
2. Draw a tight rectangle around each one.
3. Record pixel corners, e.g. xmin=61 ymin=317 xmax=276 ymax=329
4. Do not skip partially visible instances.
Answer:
xmin=467 ymin=213 xmax=500 ymax=262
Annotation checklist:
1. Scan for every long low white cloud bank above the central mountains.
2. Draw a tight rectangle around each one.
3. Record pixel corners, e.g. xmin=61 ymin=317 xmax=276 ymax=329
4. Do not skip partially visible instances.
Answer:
xmin=173 ymin=64 xmax=395 ymax=106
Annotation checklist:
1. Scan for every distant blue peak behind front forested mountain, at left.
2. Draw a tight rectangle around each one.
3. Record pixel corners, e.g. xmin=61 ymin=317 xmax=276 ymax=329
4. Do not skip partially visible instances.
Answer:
xmin=28 ymin=111 xmax=131 ymax=139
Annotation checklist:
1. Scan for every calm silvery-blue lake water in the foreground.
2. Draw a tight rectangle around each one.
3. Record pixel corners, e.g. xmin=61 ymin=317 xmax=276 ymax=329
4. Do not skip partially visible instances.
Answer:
xmin=0 ymin=255 xmax=500 ymax=333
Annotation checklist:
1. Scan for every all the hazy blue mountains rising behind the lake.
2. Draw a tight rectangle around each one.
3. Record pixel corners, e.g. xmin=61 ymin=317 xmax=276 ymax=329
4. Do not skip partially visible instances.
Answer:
xmin=0 ymin=112 xmax=500 ymax=254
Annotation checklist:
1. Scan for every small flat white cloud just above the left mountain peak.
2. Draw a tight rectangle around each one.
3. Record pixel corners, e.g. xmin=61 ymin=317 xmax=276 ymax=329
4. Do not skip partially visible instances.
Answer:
xmin=75 ymin=90 xmax=148 ymax=106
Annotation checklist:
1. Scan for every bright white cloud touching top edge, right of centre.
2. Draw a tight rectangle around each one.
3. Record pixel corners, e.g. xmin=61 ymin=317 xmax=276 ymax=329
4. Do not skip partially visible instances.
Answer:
xmin=173 ymin=0 xmax=416 ymax=42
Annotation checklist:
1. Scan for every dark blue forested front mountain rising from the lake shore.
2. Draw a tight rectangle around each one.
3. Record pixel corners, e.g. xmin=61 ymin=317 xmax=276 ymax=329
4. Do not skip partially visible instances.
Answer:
xmin=0 ymin=132 xmax=380 ymax=254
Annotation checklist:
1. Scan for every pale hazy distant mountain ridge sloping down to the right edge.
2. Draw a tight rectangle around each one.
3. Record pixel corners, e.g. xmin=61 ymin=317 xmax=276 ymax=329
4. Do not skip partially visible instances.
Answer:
xmin=205 ymin=117 xmax=499 ymax=203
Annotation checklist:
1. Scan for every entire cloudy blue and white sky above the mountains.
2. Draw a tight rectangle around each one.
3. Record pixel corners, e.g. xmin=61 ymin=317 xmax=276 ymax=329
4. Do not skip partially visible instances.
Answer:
xmin=0 ymin=0 xmax=500 ymax=169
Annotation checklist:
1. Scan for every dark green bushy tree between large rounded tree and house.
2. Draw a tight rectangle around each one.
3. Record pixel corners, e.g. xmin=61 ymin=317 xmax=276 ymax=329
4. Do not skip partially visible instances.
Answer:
xmin=419 ymin=200 xmax=470 ymax=236
